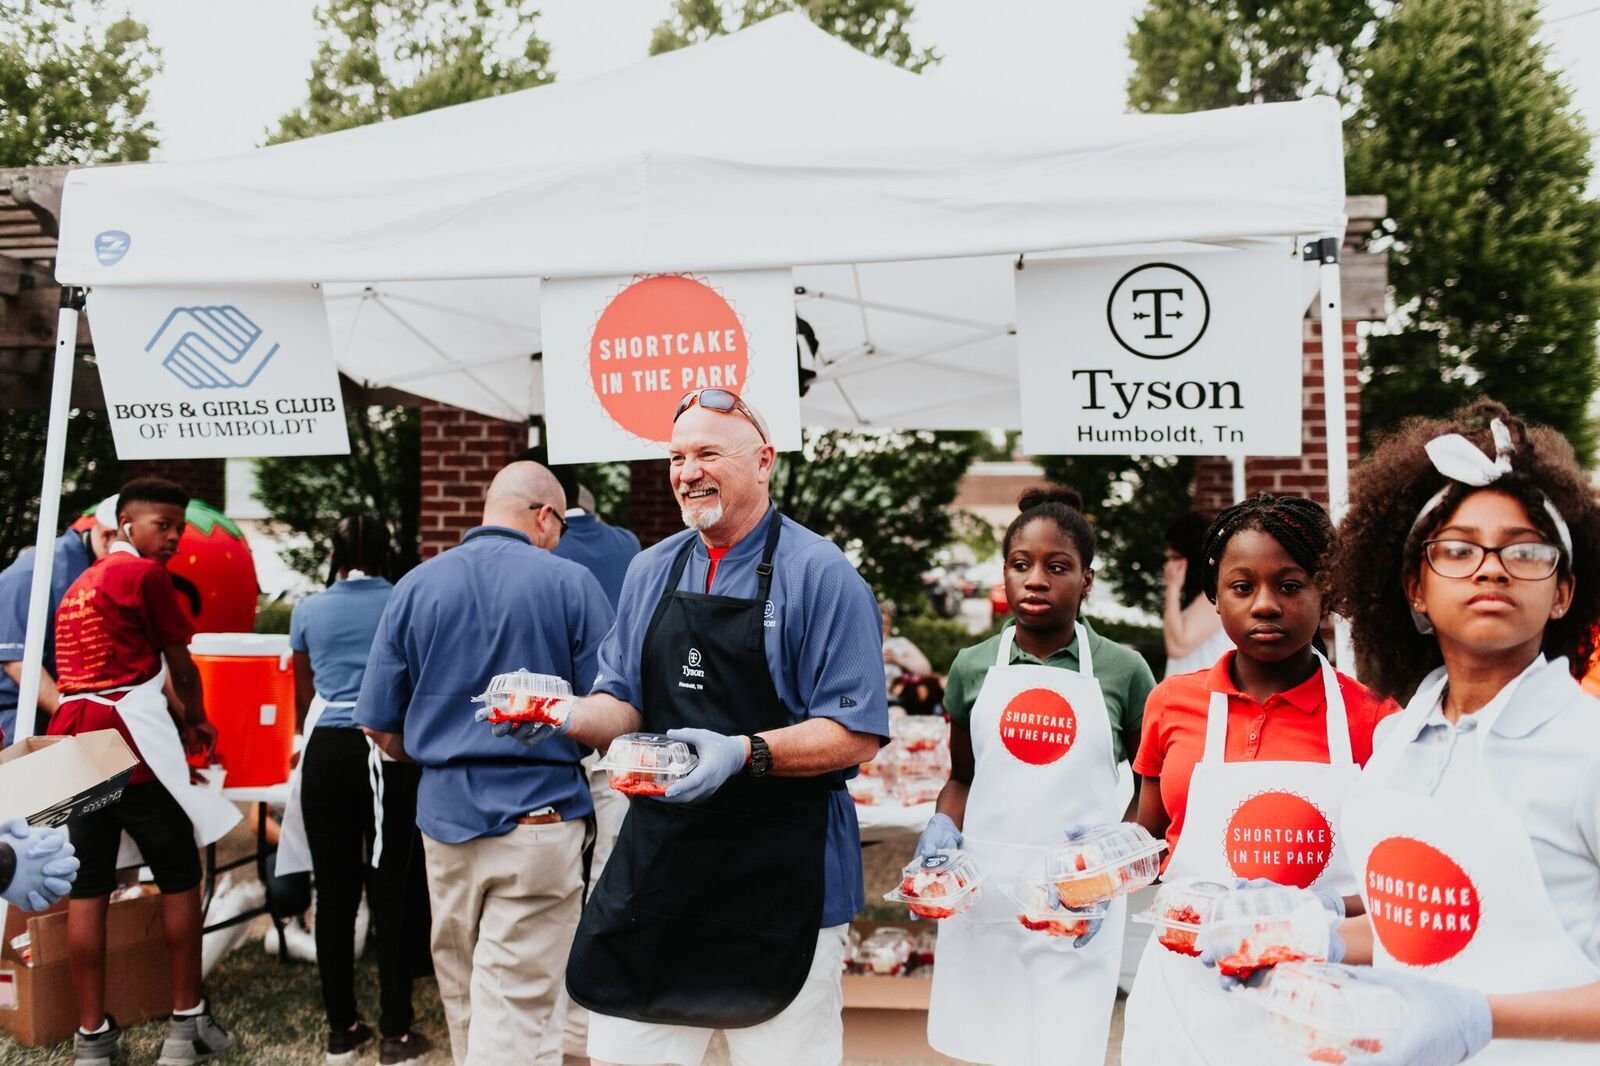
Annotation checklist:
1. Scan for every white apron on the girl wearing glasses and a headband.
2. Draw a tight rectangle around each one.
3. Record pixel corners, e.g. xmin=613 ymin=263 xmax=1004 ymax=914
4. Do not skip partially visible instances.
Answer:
xmin=1344 ymin=656 xmax=1600 ymax=1066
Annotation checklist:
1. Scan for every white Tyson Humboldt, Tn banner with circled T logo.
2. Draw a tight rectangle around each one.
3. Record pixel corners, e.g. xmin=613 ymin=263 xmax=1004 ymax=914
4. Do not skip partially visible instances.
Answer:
xmin=1016 ymin=240 xmax=1307 ymax=456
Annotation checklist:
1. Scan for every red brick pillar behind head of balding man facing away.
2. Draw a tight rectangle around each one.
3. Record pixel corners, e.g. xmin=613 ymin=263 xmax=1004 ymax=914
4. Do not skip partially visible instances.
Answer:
xmin=419 ymin=402 xmax=528 ymax=559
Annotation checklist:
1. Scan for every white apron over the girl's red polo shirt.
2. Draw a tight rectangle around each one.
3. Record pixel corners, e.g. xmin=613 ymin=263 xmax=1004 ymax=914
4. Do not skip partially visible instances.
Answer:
xmin=1122 ymin=655 xmax=1360 ymax=1066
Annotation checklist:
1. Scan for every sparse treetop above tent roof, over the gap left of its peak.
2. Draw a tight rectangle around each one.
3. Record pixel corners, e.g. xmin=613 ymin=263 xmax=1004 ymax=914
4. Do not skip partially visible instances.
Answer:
xmin=272 ymin=0 xmax=554 ymax=142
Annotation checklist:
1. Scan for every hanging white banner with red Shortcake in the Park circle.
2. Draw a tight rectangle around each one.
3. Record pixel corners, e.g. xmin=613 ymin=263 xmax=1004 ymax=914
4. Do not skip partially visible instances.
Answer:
xmin=539 ymin=271 xmax=800 ymax=463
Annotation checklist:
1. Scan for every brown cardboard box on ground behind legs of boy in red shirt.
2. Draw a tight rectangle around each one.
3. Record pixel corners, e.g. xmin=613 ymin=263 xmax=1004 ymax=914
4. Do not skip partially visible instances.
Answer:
xmin=0 ymin=877 xmax=173 ymax=1045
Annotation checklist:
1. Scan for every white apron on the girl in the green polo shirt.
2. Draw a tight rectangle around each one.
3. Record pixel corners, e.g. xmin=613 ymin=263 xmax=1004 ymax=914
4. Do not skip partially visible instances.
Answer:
xmin=928 ymin=624 xmax=1126 ymax=1066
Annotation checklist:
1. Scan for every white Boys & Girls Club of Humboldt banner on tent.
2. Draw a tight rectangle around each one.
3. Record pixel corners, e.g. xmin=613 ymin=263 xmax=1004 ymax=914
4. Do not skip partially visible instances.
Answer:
xmin=86 ymin=285 xmax=350 ymax=459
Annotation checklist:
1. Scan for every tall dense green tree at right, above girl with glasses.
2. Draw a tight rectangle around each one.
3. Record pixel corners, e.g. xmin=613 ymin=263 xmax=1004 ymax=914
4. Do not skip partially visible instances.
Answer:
xmin=1347 ymin=0 xmax=1600 ymax=458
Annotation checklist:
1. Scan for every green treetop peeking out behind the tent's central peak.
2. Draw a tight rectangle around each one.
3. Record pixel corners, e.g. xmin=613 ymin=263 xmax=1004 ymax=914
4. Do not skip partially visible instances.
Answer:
xmin=650 ymin=0 xmax=939 ymax=70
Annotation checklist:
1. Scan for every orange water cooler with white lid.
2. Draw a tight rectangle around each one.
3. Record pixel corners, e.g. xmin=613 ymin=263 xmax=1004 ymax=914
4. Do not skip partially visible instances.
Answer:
xmin=189 ymin=632 xmax=294 ymax=787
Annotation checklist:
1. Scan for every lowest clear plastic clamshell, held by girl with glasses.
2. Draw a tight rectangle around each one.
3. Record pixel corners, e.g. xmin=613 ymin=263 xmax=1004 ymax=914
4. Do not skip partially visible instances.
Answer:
xmin=1254 ymin=962 xmax=1410 ymax=1063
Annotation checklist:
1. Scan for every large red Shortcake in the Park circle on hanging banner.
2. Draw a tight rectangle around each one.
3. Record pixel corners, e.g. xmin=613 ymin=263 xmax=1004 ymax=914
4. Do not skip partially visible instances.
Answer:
xmin=589 ymin=274 xmax=750 ymax=443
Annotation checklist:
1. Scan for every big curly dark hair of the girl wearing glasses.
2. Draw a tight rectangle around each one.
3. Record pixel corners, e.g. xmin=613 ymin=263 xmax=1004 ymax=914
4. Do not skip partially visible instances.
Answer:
xmin=1322 ymin=400 xmax=1600 ymax=696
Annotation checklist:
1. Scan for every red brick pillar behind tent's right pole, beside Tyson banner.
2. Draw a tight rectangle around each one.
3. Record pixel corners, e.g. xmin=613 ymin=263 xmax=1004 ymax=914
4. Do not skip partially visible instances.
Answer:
xmin=1194 ymin=319 xmax=1362 ymax=514
